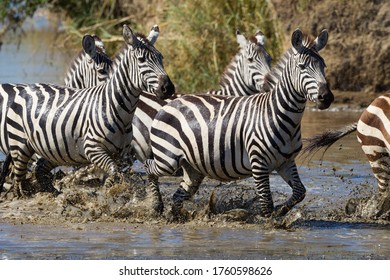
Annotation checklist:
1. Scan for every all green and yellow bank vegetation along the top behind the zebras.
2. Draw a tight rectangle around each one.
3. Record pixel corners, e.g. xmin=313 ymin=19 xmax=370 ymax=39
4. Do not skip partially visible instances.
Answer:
xmin=0 ymin=0 xmax=283 ymax=92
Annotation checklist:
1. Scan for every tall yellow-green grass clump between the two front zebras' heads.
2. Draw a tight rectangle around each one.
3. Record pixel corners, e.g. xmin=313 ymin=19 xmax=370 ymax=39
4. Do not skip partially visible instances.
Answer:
xmin=159 ymin=0 xmax=282 ymax=93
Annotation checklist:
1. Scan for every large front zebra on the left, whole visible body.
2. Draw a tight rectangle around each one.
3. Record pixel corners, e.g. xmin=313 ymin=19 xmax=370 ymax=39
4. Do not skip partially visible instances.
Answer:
xmin=5 ymin=25 xmax=175 ymax=197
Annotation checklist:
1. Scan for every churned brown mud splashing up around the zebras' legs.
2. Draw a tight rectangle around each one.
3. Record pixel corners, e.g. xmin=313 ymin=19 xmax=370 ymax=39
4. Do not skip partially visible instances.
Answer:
xmin=0 ymin=155 xmax=390 ymax=229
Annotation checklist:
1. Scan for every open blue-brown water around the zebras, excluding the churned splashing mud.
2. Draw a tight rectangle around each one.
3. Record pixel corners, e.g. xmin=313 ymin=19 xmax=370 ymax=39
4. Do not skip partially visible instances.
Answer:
xmin=0 ymin=29 xmax=390 ymax=259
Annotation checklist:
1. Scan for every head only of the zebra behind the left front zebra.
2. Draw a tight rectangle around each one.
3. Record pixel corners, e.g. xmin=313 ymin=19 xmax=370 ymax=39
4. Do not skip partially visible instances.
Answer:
xmin=80 ymin=35 xmax=112 ymax=88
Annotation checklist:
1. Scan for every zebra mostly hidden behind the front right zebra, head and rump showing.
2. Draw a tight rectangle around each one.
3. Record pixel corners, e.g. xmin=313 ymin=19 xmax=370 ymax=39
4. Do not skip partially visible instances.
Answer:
xmin=132 ymin=31 xmax=271 ymax=162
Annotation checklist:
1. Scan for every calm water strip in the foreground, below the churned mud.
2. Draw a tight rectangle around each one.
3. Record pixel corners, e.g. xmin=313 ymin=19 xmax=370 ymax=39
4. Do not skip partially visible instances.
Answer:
xmin=0 ymin=221 xmax=390 ymax=259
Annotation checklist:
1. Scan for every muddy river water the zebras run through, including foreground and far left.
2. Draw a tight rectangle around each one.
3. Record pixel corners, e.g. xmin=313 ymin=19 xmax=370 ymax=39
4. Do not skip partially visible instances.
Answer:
xmin=0 ymin=31 xmax=390 ymax=259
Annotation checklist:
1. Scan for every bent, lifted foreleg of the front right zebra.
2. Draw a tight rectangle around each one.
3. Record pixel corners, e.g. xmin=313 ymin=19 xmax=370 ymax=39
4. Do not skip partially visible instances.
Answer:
xmin=275 ymin=162 xmax=306 ymax=216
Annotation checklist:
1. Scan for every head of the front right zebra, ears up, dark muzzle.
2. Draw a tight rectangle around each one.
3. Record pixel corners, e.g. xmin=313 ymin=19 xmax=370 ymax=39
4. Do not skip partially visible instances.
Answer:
xmin=291 ymin=29 xmax=334 ymax=110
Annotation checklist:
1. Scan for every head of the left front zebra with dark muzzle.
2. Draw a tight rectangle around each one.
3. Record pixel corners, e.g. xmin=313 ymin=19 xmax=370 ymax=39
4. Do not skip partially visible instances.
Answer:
xmin=123 ymin=25 xmax=175 ymax=99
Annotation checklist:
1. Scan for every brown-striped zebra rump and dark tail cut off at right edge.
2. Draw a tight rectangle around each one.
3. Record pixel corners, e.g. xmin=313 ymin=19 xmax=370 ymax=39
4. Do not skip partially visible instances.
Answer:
xmin=303 ymin=93 xmax=390 ymax=193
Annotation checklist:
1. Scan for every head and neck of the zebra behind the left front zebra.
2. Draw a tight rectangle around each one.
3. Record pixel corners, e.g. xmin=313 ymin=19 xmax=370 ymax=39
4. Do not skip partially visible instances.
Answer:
xmin=65 ymin=35 xmax=113 ymax=88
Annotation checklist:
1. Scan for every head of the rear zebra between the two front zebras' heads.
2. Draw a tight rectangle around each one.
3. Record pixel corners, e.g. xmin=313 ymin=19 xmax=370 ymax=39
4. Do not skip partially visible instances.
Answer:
xmin=236 ymin=30 xmax=272 ymax=91
